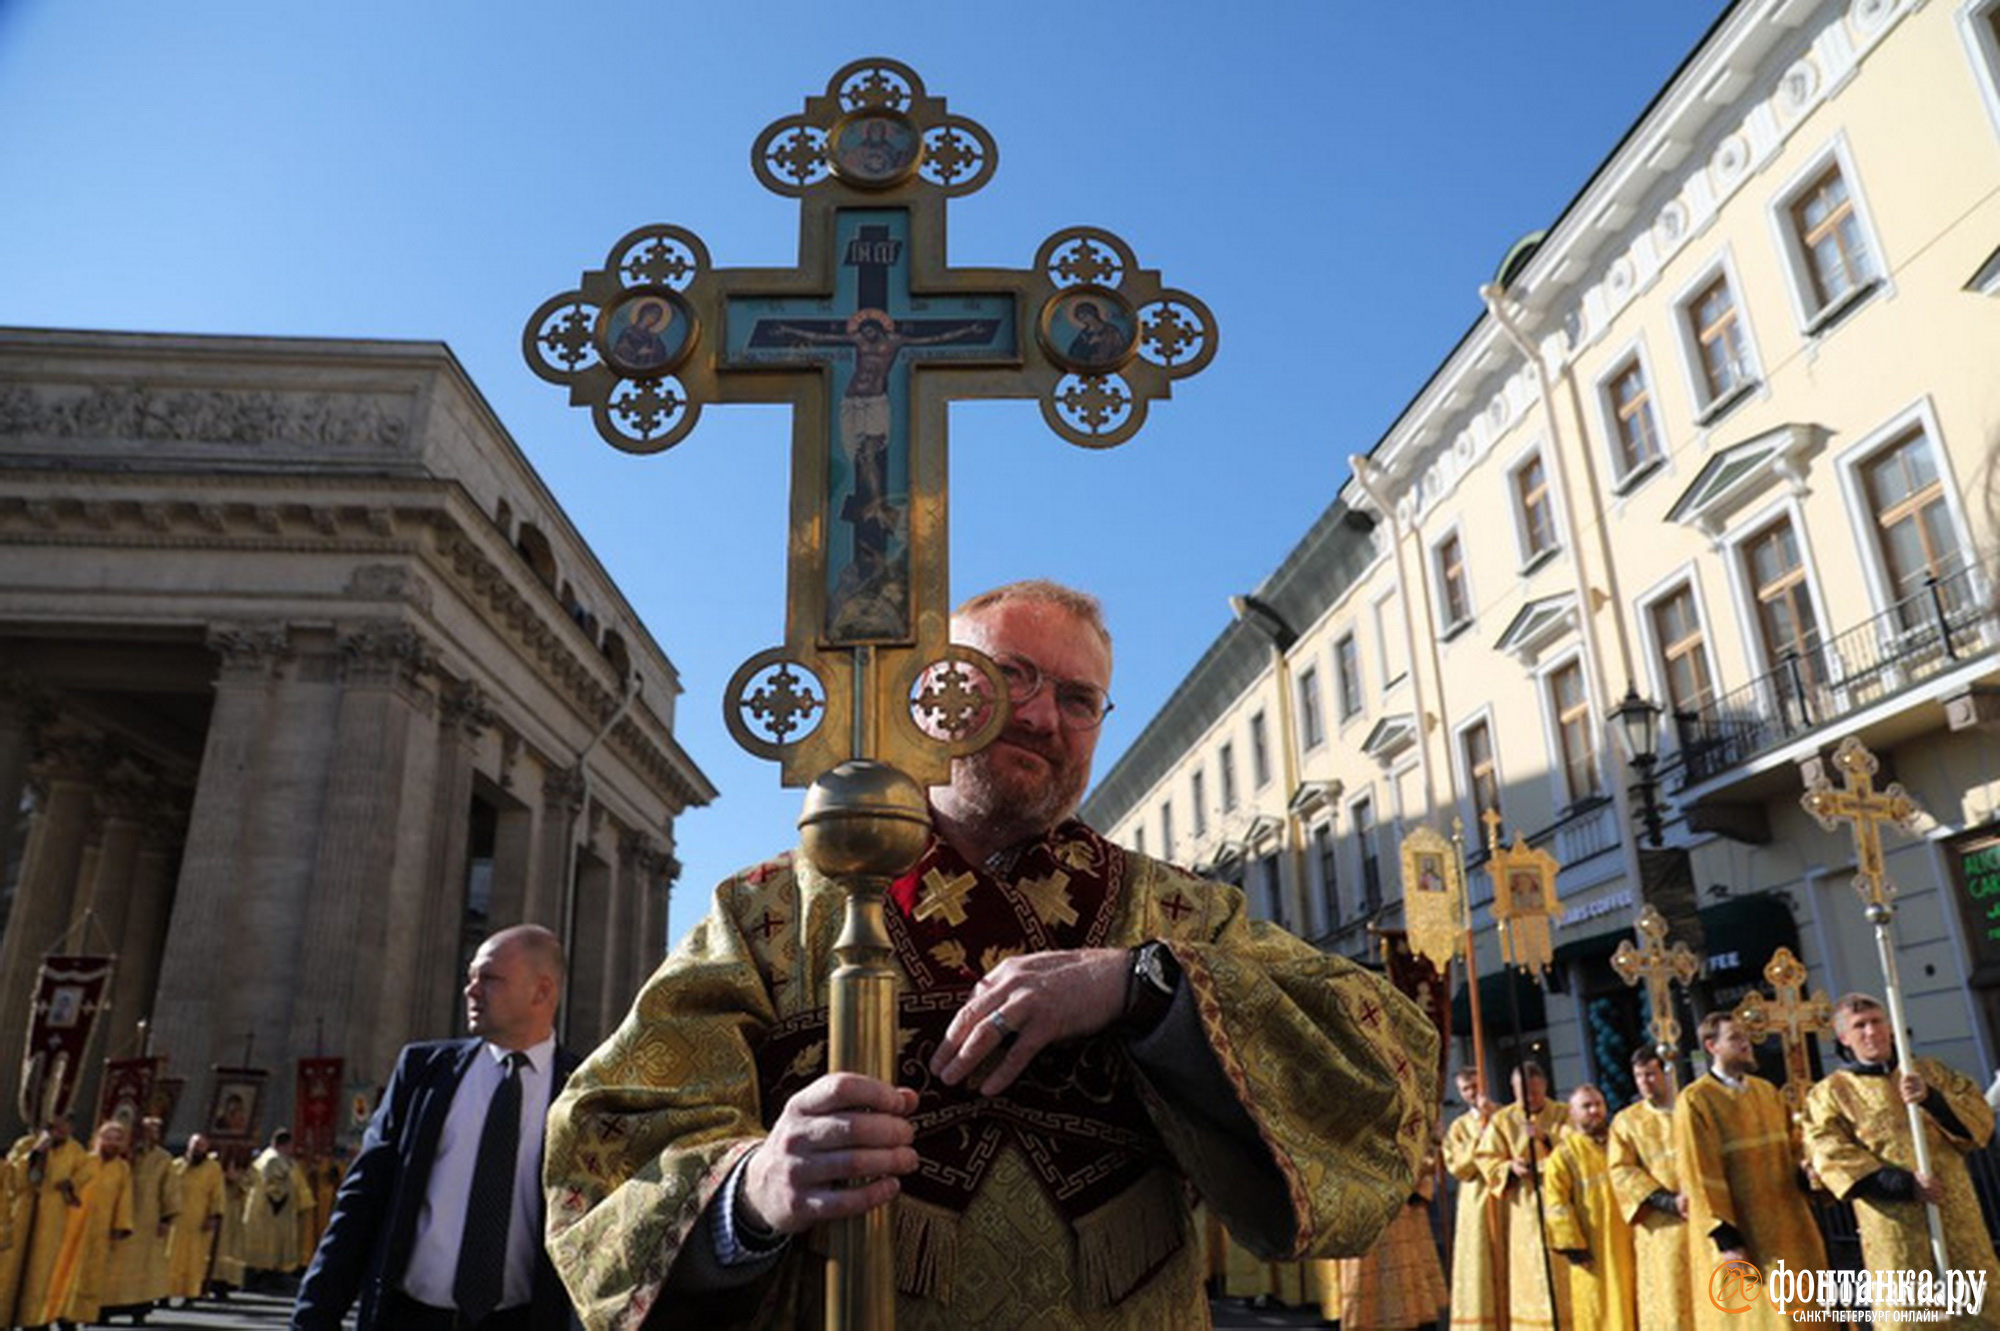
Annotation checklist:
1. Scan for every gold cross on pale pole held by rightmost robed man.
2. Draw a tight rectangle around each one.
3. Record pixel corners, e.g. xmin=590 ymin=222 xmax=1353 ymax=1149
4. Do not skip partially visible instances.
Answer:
xmin=1798 ymin=735 xmax=1952 ymax=1275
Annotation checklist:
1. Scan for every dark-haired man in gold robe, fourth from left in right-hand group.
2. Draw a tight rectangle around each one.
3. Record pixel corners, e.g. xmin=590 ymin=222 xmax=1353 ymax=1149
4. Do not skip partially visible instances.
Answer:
xmin=1604 ymin=1049 xmax=1706 ymax=1331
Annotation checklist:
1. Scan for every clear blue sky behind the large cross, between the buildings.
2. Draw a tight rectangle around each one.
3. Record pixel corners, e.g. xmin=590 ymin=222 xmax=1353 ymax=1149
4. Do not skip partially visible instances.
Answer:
xmin=0 ymin=0 xmax=1726 ymax=937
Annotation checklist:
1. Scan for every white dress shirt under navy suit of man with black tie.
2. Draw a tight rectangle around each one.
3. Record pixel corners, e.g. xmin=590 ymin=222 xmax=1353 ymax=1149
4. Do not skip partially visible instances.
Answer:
xmin=402 ymin=1035 xmax=556 ymax=1307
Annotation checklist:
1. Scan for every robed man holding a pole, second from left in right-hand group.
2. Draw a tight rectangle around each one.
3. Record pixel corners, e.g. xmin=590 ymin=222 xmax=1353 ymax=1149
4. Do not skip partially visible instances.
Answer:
xmin=1474 ymin=1061 xmax=1576 ymax=1331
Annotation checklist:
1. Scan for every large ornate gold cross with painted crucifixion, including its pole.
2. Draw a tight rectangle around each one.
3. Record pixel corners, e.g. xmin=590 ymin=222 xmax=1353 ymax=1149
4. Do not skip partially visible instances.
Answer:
xmin=522 ymin=58 xmax=1216 ymax=1327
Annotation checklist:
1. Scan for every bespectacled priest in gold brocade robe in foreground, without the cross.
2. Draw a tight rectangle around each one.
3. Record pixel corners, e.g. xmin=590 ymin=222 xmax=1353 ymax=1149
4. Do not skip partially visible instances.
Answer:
xmin=544 ymin=584 xmax=1438 ymax=1331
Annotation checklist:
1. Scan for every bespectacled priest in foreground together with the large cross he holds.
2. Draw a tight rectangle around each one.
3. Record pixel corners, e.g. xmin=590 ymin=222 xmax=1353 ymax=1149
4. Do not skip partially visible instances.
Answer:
xmin=524 ymin=60 xmax=1436 ymax=1331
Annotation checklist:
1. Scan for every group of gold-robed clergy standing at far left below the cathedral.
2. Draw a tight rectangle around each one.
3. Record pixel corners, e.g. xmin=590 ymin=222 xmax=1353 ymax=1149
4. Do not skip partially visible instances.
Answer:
xmin=0 ymin=1115 xmax=340 ymax=1327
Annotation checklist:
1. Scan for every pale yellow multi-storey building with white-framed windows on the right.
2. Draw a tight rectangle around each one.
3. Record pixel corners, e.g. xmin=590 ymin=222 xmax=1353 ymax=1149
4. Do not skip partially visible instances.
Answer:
xmin=1084 ymin=0 xmax=2000 ymax=1089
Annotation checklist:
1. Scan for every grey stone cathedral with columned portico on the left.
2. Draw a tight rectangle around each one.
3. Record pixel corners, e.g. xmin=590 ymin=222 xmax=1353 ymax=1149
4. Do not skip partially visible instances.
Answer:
xmin=0 ymin=330 xmax=716 ymax=1135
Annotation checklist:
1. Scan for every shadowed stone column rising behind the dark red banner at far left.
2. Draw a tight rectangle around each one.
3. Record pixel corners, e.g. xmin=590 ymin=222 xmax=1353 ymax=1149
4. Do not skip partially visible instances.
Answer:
xmin=0 ymin=721 xmax=104 ymax=1127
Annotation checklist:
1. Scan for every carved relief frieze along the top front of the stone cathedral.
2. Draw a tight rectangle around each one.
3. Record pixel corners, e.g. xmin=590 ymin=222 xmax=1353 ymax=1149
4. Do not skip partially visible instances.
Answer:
xmin=0 ymin=384 xmax=410 ymax=452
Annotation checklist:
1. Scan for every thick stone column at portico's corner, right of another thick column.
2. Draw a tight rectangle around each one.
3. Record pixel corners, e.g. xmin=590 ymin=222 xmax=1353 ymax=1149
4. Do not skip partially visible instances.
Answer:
xmin=290 ymin=620 xmax=436 ymax=1079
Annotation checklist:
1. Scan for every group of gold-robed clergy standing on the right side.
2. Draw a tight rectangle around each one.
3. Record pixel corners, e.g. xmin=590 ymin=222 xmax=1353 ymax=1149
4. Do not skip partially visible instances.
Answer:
xmin=1208 ymin=993 xmax=2000 ymax=1331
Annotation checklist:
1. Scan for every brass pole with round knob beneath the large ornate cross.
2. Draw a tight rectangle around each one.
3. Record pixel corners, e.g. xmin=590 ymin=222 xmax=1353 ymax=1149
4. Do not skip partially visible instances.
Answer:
xmin=798 ymin=759 xmax=930 ymax=1331
